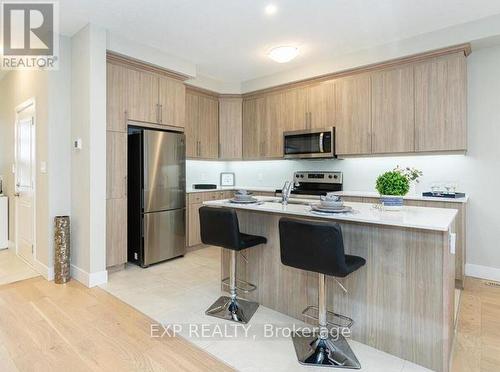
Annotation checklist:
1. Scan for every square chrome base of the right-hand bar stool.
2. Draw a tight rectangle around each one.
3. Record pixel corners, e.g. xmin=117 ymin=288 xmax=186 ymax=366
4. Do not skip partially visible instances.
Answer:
xmin=292 ymin=332 xmax=361 ymax=369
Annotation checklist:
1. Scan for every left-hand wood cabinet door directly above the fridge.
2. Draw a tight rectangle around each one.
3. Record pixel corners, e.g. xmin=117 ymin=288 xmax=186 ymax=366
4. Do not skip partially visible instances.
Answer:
xmin=127 ymin=69 xmax=159 ymax=123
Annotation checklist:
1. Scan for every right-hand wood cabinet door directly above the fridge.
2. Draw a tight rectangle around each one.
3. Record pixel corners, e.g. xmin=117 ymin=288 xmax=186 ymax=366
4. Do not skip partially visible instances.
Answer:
xmin=159 ymin=77 xmax=186 ymax=127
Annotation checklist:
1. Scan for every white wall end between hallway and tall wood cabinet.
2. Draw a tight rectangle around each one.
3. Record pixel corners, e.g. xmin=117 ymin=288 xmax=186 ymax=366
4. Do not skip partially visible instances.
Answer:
xmin=71 ymin=25 xmax=107 ymax=286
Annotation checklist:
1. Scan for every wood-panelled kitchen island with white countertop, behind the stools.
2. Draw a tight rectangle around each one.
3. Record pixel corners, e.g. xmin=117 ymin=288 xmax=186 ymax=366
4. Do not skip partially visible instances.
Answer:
xmin=205 ymin=197 xmax=457 ymax=371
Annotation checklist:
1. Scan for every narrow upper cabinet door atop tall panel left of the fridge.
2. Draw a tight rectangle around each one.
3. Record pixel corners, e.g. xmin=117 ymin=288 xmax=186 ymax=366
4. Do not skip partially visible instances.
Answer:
xmin=106 ymin=63 xmax=128 ymax=132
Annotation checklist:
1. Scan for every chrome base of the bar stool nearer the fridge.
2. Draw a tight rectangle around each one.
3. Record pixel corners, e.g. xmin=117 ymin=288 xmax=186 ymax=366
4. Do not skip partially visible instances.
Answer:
xmin=205 ymin=296 xmax=259 ymax=324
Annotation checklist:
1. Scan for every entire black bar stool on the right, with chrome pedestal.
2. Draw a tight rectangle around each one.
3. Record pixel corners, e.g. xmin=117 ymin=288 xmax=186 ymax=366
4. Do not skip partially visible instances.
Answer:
xmin=279 ymin=218 xmax=366 ymax=369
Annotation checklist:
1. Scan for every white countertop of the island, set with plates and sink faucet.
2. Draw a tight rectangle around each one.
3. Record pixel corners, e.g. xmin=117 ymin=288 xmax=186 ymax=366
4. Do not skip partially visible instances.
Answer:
xmin=203 ymin=197 xmax=457 ymax=231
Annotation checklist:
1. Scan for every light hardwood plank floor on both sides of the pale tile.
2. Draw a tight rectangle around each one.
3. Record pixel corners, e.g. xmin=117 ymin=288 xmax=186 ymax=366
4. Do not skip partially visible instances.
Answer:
xmin=0 ymin=255 xmax=500 ymax=372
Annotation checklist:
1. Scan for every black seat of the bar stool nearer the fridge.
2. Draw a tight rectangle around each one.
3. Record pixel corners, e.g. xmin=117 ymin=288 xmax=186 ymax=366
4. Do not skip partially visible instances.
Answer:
xmin=200 ymin=206 xmax=267 ymax=251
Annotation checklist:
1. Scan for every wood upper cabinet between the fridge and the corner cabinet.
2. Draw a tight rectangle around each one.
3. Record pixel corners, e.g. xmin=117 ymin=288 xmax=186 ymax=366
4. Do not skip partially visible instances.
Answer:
xmin=184 ymin=90 xmax=219 ymax=159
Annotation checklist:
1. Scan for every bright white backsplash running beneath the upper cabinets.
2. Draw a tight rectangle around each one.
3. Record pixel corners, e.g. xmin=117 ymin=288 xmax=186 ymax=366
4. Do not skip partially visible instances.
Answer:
xmin=187 ymin=155 xmax=473 ymax=194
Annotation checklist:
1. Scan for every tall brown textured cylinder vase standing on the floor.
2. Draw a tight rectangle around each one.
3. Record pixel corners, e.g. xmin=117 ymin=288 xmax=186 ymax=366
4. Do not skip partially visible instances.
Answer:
xmin=54 ymin=216 xmax=70 ymax=284
